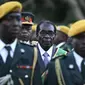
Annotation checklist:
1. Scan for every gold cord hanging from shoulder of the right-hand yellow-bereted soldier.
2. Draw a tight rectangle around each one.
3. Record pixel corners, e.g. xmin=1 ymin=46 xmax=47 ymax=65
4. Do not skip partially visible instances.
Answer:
xmin=55 ymin=59 xmax=66 ymax=85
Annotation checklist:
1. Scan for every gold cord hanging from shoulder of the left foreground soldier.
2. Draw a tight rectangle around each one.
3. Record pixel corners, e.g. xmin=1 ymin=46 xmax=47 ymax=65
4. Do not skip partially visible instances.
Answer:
xmin=30 ymin=47 xmax=38 ymax=85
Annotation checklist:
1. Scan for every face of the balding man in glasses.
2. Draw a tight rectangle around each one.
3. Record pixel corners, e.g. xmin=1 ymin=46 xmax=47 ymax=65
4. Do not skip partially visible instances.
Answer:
xmin=38 ymin=23 xmax=55 ymax=50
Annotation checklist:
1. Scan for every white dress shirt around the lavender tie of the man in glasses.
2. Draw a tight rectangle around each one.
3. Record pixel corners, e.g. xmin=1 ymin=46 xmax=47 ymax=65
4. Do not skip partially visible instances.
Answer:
xmin=38 ymin=43 xmax=53 ymax=61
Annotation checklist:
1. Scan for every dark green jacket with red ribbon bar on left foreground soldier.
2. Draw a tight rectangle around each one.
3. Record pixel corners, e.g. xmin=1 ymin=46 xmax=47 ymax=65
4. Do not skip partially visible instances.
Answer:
xmin=0 ymin=42 xmax=42 ymax=85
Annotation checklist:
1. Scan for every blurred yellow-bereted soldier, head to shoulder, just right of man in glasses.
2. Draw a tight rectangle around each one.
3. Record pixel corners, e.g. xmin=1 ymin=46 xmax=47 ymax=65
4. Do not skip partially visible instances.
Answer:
xmin=54 ymin=25 xmax=72 ymax=52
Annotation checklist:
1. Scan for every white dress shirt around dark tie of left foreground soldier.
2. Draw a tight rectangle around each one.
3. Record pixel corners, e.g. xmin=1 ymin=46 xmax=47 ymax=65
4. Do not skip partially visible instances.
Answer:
xmin=0 ymin=39 xmax=17 ymax=63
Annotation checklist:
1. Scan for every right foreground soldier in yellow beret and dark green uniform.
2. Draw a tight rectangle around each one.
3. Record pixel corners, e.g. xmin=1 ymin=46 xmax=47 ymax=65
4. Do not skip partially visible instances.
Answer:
xmin=44 ymin=20 xmax=85 ymax=85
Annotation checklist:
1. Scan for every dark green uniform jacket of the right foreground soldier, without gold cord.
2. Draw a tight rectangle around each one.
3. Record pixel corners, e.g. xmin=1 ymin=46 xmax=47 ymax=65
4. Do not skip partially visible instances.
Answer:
xmin=44 ymin=52 xmax=83 ymax=85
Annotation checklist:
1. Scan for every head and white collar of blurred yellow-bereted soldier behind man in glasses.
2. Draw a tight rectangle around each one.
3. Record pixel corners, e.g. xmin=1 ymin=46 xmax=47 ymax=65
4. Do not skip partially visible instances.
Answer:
xmin=54 ymin=25 xmax=69 ymax=48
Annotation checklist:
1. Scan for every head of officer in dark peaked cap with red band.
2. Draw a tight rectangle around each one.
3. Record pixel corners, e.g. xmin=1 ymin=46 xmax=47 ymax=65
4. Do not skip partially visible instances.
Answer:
xmin=18 ymin=12 xmax=34 ymax=44
